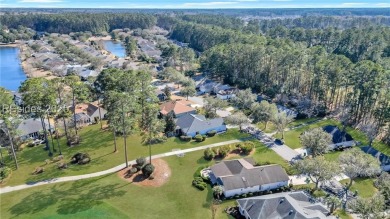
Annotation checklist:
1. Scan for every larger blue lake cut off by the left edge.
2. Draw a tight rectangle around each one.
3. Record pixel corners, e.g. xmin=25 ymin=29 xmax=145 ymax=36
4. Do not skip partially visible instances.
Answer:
xmin=0 ymin=47 xmax=26 ymax=91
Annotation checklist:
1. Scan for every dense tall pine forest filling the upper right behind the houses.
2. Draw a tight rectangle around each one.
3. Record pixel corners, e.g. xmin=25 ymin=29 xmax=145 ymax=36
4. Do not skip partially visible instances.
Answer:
xmin=158 ymin=15 xmax=390 ymax=143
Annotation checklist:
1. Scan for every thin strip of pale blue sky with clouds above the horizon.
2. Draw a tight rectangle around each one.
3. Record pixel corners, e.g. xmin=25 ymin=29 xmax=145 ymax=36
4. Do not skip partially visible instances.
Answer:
xmin=0 ymin=0 xmax=390 ymax=9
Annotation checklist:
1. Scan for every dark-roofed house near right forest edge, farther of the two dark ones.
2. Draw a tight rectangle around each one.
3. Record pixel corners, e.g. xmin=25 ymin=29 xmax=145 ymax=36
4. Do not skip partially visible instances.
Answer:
xmin=322 ymin=125 xmax=356 ymax=150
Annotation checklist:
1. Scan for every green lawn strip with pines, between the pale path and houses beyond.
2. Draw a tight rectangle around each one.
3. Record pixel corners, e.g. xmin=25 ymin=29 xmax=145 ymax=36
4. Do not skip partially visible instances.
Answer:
xmin=1 ymin=125 xmax=248 ymax=186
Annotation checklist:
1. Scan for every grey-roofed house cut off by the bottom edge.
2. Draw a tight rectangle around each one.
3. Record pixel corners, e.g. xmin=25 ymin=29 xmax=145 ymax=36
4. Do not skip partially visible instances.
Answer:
xmin=237 ymin=191 xmax=330 ymax=219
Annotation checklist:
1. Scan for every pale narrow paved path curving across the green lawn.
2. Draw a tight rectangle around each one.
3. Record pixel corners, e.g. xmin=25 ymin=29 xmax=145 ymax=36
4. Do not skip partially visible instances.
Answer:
xmin=0 ymin=139 xmax=242 ymax=194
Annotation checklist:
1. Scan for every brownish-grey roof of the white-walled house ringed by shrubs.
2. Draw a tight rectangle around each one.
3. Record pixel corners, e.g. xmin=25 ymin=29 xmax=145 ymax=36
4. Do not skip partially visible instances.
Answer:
xmin=211 ymin=159 xmax=289 ymax=190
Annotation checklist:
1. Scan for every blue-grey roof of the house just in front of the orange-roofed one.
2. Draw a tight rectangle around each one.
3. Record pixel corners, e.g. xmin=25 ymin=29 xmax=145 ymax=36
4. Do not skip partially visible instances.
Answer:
xmin=176 ymin=114 xmax=224 ymax=133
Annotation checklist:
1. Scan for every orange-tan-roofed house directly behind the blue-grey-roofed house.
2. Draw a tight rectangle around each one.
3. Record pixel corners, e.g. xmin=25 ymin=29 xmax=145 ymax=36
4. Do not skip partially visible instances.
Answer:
xmin=160 ymin=100 xmax=196 ymax=118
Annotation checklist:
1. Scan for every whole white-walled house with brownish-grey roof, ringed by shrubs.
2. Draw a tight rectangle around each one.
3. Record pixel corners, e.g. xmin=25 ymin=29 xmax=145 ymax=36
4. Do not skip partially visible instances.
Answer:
xmin=209 ymin=158 xmax=289 ymax=197
